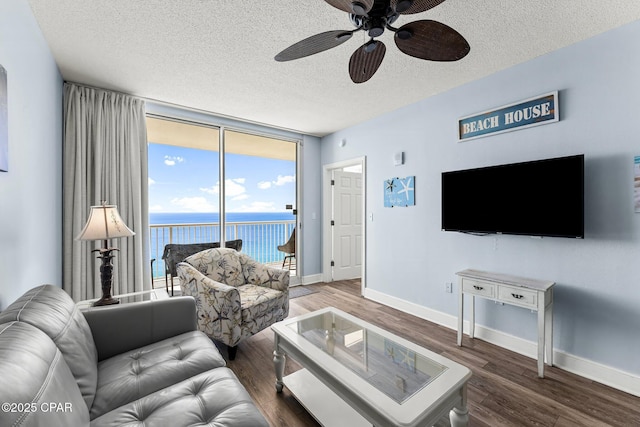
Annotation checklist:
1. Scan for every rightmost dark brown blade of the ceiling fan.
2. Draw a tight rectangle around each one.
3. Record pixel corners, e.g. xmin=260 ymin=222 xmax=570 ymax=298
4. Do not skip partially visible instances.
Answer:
xmin=394 ymin=20 xmax=471 ymax=61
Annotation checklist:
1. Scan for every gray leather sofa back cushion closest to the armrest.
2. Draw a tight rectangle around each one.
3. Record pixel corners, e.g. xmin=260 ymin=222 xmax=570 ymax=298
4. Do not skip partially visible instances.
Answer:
xmin=0 ymin=285 xmax=98 ymax=408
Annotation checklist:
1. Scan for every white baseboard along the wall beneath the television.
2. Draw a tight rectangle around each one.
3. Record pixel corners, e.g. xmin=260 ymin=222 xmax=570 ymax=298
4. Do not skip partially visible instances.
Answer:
xmin=364 ymin=289 xmax=640 ymax=397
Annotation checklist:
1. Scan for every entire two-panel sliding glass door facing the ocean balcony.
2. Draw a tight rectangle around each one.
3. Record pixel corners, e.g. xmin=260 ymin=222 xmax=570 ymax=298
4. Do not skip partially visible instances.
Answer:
xmin=147 ymin=117 xmax=297 ymax=286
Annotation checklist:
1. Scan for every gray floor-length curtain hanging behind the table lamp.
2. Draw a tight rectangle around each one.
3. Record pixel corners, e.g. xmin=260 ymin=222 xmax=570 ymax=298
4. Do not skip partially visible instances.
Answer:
xmin=62 ymin=83 xmax=151 ymax=301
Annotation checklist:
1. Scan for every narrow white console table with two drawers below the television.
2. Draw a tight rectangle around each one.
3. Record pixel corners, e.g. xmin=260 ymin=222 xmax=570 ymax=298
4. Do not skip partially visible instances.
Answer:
xmin=456 ymin=270 xmax=555 ymax=378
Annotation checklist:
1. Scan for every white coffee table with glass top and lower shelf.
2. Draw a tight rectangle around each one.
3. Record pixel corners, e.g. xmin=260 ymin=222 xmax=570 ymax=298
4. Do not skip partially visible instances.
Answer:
xmin=271 ymin=307 xmax=471 ymax=427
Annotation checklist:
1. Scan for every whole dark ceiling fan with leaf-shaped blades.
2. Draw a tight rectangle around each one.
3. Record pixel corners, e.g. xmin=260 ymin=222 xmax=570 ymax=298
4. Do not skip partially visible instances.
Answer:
xmin=275 ymin=0 xmax=471 ymax=83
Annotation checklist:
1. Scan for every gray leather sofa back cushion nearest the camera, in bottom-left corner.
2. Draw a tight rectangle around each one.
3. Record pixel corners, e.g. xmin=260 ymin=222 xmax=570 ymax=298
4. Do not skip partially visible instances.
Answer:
xmin=0 ymin=322 xmax=89 ymax=426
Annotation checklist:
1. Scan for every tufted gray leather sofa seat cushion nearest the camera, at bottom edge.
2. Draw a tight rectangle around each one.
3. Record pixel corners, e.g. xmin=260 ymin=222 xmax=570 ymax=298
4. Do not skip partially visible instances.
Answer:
xmin=91 ymin=368 xmax=269 ymax=427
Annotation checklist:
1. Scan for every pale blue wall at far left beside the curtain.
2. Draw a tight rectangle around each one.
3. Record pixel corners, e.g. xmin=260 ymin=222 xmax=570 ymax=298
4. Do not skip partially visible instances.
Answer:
xmin=0 ymin=0 xmax=62 ymax=310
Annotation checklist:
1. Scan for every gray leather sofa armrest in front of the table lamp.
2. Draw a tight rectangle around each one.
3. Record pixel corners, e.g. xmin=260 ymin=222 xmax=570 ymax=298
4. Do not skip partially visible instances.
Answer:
xmin=83 ymin=296 xmax=197 ymax=361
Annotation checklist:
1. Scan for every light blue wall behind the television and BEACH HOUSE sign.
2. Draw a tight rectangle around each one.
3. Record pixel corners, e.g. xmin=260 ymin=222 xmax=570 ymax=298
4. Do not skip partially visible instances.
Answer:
xmin=322 ymin=22 xmax=640 ymax=375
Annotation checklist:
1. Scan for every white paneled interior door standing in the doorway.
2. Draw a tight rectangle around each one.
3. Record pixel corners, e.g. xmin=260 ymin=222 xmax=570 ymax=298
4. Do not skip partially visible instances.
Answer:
xmin=332 ymin=170 xmax=363 ymax=280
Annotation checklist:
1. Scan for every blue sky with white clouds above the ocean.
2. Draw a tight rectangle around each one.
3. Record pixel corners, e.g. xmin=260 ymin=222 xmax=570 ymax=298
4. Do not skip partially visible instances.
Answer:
xmin=149 ymin=143 xmax=296 ymax=212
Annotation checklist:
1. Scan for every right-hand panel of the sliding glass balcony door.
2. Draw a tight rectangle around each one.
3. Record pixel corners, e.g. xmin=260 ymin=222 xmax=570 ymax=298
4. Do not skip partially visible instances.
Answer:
xmin=224 ymin=130 xmax=297 ymax=276
